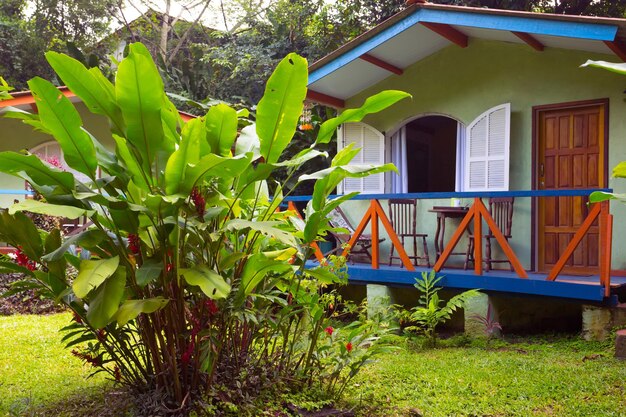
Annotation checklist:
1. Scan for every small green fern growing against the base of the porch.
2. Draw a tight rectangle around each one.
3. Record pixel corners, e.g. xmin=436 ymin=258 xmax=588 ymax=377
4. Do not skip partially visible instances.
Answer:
xmin=406 ymin=271 xmax=479 ymax=347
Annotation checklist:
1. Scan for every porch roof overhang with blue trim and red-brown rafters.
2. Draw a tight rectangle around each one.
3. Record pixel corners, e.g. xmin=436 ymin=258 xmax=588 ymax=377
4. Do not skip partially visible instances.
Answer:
xmin=308 ymin=3 xmax=626 ymax=108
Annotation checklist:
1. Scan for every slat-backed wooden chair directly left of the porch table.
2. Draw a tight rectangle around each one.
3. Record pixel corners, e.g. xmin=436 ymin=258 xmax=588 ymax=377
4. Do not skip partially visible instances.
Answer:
xmin=389 ymin=198 xmax=430 ymax=268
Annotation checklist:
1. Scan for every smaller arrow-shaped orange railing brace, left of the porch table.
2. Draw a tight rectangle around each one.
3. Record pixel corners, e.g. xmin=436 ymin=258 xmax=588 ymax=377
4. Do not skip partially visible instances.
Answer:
xmin=342 ymin=200 xmax=415 ymax=271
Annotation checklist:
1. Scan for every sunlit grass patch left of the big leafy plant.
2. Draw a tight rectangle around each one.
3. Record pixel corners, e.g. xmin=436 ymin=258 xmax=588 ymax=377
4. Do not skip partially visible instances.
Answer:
xmin=0 ymin=313 xmax=110 ymax=416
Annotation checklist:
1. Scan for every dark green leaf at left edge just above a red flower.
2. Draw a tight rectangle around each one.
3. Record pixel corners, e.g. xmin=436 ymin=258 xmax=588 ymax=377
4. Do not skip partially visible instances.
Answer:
xmin=0 ymin=210 xmax=43 ymax=260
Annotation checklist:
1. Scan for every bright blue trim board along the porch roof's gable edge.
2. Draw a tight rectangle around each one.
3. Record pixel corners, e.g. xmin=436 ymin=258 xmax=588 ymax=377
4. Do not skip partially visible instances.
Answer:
xmin=309 ymin=9 xmax=617 ymax=85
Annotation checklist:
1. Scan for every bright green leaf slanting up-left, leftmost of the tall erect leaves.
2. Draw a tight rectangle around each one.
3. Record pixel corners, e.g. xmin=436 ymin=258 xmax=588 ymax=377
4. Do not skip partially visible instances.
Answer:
xmin=28 ymin=77 xmax=98 ymax=179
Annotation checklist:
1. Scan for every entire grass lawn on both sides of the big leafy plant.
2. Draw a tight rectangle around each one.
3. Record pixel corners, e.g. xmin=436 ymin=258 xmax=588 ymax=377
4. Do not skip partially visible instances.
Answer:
xmin=0 ymin=314 xmax=626 ymax=417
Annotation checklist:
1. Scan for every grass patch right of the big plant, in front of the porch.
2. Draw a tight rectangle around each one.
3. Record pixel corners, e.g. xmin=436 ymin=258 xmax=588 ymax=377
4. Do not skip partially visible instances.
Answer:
xmin=344 ymin=338 xmax=626 ymax=417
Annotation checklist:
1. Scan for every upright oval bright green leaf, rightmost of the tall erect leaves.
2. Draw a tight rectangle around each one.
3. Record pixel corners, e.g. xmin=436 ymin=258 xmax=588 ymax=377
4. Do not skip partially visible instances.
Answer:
xmin=256 ymin=53 xmax=308 ymax=164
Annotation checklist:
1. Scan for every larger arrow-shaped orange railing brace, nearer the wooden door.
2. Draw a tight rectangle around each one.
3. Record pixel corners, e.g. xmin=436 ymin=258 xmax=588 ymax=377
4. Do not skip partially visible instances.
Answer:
xmin=434 ymin=197 xmax=528 ymax=278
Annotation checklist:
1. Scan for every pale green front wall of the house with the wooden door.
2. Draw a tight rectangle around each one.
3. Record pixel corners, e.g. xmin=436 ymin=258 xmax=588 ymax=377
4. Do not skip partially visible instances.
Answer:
xmin=336 ymin=40 xmax=626 ymax=269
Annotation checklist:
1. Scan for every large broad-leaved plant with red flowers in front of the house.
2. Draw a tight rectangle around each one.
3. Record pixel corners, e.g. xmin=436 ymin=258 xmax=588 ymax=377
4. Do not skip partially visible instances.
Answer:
xmin=0 ymin=43 xmax=409 ymax=407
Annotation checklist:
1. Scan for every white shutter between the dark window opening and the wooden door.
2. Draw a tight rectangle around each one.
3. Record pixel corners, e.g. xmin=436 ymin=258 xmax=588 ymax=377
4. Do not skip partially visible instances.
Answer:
xmin=464 ymin=103 xmax=511 ymax=191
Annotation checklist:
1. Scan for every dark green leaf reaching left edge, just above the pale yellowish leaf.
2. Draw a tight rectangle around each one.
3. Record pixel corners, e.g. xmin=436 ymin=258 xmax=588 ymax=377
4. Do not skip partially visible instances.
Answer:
xmin=0 ymin=151 xmax=74 ymax=194
